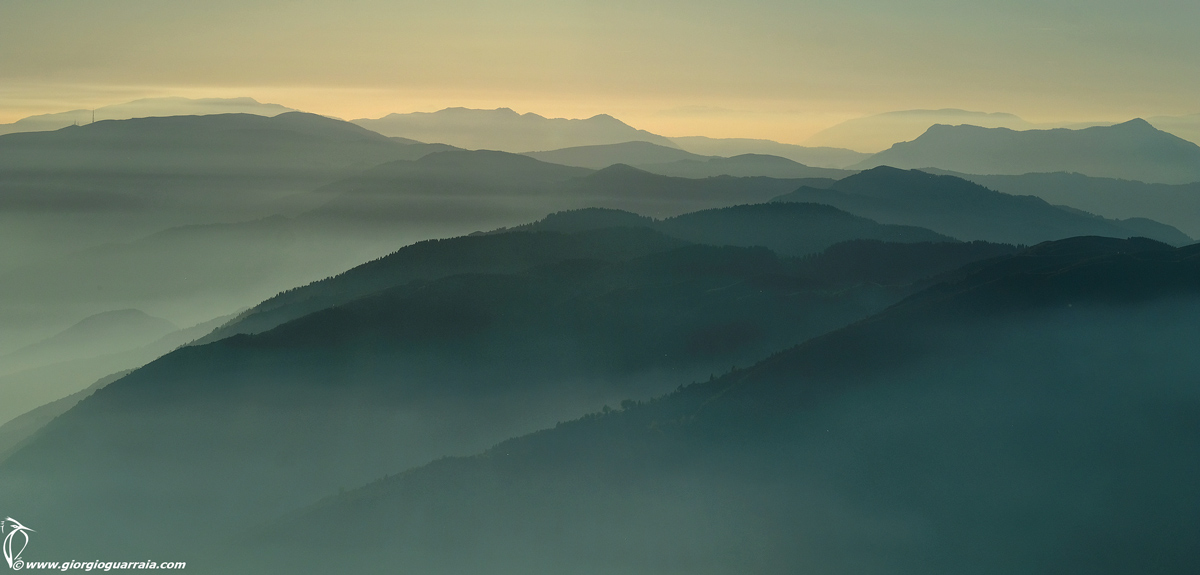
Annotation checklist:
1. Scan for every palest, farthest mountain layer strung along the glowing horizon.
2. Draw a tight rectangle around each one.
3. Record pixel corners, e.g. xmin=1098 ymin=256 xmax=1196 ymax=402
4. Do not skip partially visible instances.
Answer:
xmin=7 ymin=97 xmax=1200 ymax=169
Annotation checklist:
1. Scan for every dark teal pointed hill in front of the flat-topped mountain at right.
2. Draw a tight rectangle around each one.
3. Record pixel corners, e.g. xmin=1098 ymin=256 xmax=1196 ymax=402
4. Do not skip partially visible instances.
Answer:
xmin=778 ymin=167 xmax=1192 ymax=245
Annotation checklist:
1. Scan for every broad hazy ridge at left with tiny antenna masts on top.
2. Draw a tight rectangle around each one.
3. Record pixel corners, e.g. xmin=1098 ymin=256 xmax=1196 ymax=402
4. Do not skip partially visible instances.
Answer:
xmin=0 ymin=112 xmax=445 ymax=223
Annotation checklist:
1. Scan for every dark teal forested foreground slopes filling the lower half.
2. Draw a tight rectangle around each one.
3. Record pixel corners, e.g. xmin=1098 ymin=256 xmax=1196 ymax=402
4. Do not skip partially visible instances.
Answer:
xmin=0 ymin=217 xmax=1200 ymax=573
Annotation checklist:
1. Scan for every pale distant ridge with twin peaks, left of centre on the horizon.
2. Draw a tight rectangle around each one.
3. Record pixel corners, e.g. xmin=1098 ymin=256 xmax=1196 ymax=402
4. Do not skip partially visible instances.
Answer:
xmin=352 ymin=108 xmax=674 ymax=152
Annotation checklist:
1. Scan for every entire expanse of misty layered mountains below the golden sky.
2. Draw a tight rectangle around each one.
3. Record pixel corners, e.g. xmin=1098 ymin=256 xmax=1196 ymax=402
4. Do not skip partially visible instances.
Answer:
xmin=0 ymin=96 xmax=1200 ymax=575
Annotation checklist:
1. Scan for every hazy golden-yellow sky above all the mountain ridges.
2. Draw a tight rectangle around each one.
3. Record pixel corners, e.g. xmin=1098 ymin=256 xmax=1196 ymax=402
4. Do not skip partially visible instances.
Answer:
xmin=0 ymin=0 xmax=1200 ymax=142
